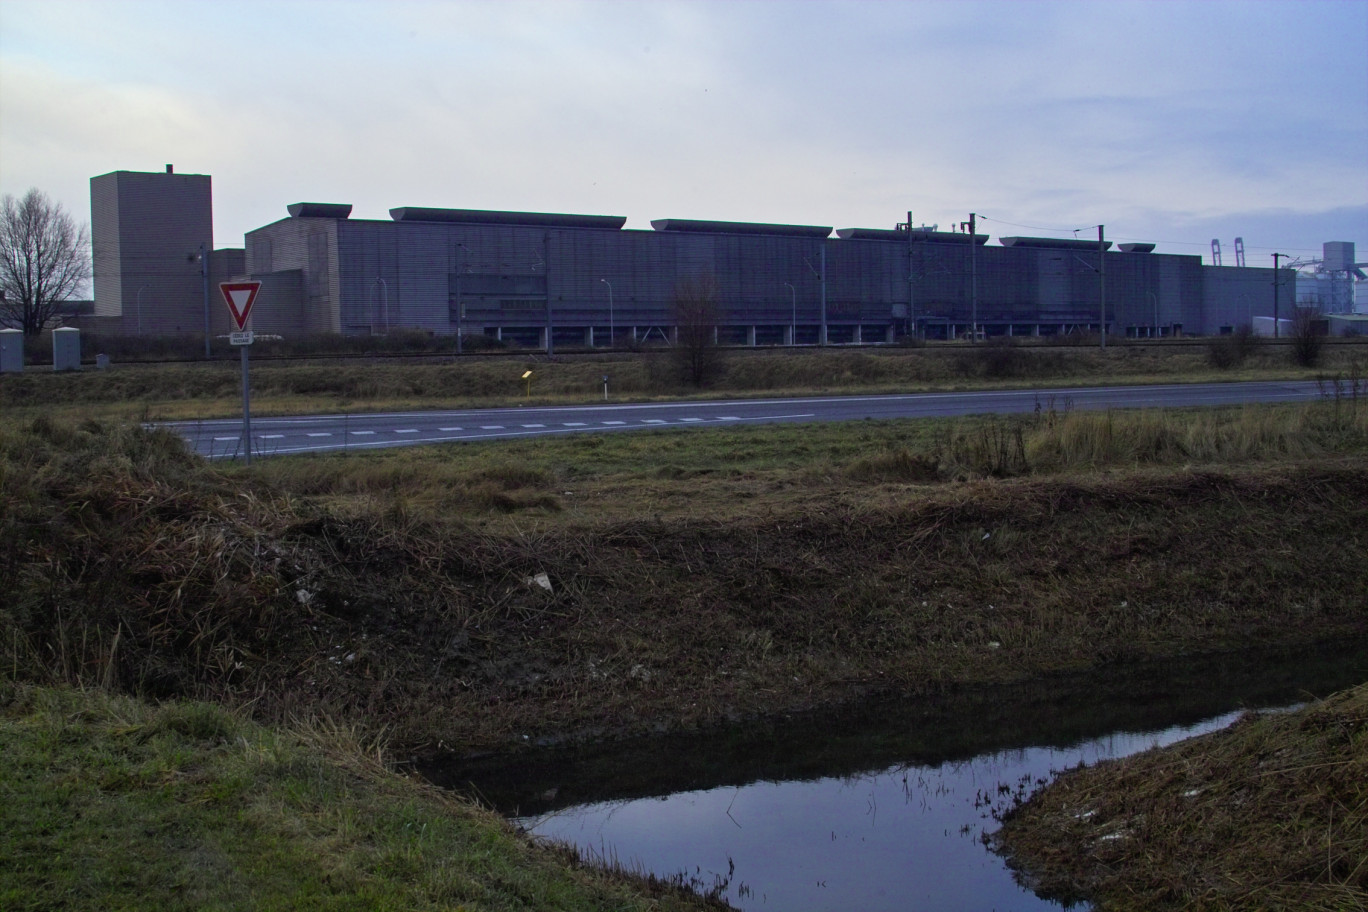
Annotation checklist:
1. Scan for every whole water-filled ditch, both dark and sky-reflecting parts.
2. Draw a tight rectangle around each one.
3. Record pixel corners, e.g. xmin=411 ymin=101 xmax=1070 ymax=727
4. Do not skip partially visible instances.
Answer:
xmin=421 ymin=641 xmax=1368 ymax=912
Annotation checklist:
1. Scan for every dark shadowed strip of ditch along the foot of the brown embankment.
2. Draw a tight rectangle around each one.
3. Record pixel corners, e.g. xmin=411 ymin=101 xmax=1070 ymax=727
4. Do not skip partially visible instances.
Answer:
xmin=415 ymin=639 xmax=1368 ymax=816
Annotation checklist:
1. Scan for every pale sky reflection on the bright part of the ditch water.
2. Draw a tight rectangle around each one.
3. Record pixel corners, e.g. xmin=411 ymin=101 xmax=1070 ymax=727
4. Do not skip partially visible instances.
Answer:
xmin=521 ymin=714 xmax=1238 ymax=912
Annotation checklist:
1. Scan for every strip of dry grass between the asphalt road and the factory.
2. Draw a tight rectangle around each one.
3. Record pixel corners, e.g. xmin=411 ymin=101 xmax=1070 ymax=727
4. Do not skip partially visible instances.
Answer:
xmin=0 ymin=340 xmax=1365 ymax=420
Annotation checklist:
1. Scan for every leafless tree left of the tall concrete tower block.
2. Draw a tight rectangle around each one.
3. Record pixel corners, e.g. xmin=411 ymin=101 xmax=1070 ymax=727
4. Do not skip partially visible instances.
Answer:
xmin=0 ymin=187 xmax=90 ymax=335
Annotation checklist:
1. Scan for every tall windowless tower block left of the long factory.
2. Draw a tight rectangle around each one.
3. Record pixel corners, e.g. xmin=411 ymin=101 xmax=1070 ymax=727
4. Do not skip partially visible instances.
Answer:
xmin=90 ymin=165 xmax=213 ymax=335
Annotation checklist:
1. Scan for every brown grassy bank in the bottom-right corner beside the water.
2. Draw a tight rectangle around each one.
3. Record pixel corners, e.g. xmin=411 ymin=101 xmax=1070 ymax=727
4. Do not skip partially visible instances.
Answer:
xmin=995 ymin=685 xmax=1368 ymax=912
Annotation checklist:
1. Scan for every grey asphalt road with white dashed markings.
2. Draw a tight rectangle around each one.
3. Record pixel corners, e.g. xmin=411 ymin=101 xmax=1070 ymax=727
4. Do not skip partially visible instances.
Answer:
xmin=161 ymin=381 xmax=1320 ymax=459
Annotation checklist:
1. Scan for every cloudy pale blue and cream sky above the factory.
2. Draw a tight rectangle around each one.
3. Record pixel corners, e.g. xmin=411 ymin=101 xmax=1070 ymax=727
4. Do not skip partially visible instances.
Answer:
xmin=0 ymin=0 xmax=1368 ymax=265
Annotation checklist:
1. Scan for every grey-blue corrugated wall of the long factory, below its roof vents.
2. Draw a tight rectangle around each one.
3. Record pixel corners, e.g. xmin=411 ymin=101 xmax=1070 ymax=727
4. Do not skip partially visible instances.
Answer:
xmin=248 ymin=211 xmax=1268 ymax=342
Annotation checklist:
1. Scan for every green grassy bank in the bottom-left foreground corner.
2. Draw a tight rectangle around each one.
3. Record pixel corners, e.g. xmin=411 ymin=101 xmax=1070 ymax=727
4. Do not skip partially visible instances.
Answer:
xmin=0 ymin=682 xmax=720 ymax=912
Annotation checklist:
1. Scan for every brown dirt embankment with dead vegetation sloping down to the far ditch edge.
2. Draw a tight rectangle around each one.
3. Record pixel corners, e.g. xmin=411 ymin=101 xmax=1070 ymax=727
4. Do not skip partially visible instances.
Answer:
xmin=0 ymin=423 xmax=1368 ymax=752
